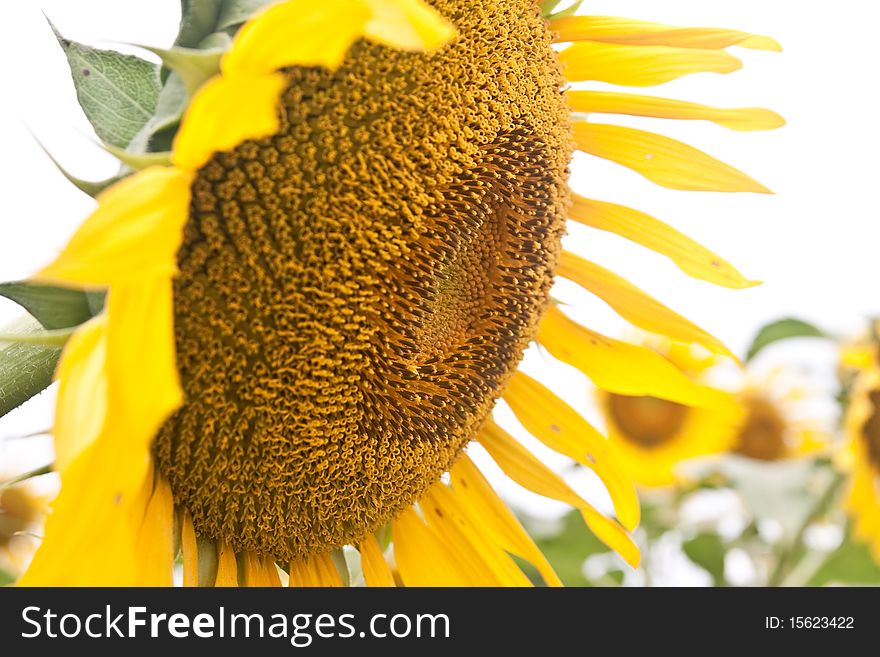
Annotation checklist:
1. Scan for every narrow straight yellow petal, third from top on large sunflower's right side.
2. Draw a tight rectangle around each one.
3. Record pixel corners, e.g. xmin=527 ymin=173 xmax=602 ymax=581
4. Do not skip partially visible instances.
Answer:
xmin=566 ymin=91 xmax=785 ymax=132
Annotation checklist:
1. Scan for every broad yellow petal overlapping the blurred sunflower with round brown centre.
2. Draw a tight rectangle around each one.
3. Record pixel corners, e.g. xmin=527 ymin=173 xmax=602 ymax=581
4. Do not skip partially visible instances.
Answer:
xmin=538 ymin=307 xmax=729 ymax=408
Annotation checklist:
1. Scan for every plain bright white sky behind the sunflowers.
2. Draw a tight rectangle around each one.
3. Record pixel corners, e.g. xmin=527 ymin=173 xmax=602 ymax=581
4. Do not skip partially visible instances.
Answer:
xmin=0 ymin=0 xmax=880 ymax=544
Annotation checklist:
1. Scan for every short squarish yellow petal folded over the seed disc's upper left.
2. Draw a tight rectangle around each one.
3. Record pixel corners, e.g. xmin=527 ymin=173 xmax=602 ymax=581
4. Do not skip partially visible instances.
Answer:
xmin=172 ymin=73 xmax=286 ymax=171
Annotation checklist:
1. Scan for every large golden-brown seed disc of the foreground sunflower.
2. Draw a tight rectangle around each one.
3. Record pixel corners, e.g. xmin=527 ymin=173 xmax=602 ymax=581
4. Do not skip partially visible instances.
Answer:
xmin=155 ymin=0 xmax=572 ymax=560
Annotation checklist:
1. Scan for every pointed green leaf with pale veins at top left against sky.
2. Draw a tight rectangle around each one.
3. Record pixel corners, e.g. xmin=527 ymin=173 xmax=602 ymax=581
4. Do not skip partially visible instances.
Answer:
xmin=49 ymin=22 xmax=161 ymax=148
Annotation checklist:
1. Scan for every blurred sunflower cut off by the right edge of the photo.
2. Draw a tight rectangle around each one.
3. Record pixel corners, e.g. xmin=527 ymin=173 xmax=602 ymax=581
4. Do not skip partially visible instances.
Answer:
xmin=841 ymin=324 xmax=880 ymax=563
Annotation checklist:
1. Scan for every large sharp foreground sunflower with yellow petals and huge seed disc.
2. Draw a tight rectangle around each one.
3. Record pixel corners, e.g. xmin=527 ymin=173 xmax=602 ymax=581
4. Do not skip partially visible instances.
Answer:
xmin=13 ymin=0 xmax=782 ymax=586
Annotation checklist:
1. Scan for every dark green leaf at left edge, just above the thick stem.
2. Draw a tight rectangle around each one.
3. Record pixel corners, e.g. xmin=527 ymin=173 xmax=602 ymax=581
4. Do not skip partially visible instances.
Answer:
xmin=0 ymin=282 xmax=96 ymax=330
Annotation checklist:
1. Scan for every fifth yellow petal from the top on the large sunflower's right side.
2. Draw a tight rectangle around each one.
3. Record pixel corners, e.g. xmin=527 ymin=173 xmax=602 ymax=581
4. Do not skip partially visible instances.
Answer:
xmin=568 ymin=194 xmax=759 ymax=290
